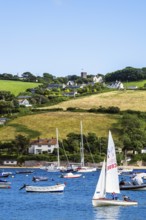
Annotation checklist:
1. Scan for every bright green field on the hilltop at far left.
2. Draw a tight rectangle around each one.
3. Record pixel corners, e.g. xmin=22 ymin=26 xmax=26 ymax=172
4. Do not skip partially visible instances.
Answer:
xmin=0 ymin=80 xmax=40 ymax=96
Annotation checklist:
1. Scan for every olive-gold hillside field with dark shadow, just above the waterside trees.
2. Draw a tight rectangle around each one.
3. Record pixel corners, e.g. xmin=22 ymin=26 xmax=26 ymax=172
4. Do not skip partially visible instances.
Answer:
xmin=0 ymin=112 xmax=119 ymax=141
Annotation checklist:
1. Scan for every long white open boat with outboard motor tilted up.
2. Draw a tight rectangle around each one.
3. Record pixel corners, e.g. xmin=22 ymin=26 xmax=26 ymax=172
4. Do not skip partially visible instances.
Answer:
xmin=20 ymin=183 xmax=66 ymax=193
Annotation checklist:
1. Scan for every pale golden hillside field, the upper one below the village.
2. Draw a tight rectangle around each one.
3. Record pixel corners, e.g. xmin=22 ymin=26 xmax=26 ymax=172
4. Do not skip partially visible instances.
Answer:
xmin=38 ymin=90 xmax=146 ymax=111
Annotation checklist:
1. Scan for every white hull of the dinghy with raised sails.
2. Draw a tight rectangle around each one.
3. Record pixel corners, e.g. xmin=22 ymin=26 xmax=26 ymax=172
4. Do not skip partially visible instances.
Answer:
xmin=92 ymin=198 xmax=138 ymax=207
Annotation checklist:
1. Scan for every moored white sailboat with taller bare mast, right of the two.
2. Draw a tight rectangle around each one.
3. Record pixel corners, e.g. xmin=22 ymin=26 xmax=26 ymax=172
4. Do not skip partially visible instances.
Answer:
xmin=78 ymin=121 xmax=97 ymax=173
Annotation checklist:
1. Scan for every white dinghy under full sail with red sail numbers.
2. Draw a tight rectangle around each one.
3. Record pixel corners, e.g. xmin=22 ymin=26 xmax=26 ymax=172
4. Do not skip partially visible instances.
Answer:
xmin=92 ymin=131 xmax=138 ymax=206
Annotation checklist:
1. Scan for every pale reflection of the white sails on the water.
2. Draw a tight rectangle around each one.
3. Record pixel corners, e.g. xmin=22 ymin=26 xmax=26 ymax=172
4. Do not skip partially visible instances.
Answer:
xmin=94 ymin=206 xmax=120 ymax=220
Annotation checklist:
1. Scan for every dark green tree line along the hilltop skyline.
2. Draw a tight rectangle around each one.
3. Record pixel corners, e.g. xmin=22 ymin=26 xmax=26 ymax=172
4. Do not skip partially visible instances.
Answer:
xmin=0 ymin=66 xmax=146 ymax=84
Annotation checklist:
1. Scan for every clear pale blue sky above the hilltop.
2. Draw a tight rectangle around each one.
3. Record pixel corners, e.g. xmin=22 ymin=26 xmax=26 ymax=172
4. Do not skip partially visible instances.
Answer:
xmin=0 ymin=0 xmax=146 ymax=76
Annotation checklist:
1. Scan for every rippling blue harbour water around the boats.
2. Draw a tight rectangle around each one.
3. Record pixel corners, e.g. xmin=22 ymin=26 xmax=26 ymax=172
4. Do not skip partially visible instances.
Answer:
xmin=0 ymin=169 xmax=146 ymax=220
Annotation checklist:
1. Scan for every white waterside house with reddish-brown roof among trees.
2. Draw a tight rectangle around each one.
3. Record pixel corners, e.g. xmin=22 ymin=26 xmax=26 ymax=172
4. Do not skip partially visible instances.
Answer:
xmin=28 ymin=138 xmax=58 ymax=154
